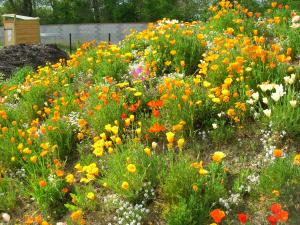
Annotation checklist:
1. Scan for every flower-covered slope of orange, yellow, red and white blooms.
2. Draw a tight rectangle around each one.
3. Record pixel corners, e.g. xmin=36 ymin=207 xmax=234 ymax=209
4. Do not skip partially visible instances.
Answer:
xmin=0 ymin=0 xmax=300 ymax=225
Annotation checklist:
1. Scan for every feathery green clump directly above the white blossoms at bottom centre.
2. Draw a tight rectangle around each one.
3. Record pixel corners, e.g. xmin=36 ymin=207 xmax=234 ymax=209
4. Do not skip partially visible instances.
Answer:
xmin=102 ymin=143 xmax=164 ymax=202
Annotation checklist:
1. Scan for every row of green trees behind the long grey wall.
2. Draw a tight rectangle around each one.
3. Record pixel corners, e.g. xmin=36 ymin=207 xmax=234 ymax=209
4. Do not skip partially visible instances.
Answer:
xmin=0 ymin=0 xmax=209 ymax=24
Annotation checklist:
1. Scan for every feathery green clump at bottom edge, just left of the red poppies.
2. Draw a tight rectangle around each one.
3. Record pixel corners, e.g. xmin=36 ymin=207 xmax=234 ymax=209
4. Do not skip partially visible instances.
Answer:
xmin=162 ymin=154 xmax=227 ymax=225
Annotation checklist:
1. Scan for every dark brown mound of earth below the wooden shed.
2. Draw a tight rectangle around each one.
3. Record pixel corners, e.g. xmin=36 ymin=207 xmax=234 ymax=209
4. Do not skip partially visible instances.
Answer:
xmin=0 ymin=44 xmax=69 ymax=78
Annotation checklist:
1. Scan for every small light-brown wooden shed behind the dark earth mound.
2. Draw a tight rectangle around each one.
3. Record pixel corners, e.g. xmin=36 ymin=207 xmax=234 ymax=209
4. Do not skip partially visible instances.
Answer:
xmin=2 ymin=14 xmax=41 ymax=46
